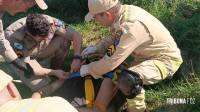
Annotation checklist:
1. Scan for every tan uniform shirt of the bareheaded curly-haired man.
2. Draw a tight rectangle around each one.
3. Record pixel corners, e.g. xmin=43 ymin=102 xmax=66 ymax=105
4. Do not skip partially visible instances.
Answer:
xmin=5 ymin=15 xmax=74 ymax=57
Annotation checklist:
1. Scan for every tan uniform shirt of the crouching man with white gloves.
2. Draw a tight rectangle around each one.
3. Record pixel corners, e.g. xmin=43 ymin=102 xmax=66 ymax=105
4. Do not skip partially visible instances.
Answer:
xmin=88 ymin=5 xmax=182 ymax=78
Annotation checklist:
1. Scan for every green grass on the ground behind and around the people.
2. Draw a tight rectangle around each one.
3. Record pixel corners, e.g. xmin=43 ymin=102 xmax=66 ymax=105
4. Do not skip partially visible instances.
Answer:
xmin=0 ymin=0 xmax=200 ymax=112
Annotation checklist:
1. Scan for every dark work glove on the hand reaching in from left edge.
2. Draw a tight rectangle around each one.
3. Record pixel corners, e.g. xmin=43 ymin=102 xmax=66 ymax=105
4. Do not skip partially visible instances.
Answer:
xmin=11 ymin=58 xmax=34 ymax=78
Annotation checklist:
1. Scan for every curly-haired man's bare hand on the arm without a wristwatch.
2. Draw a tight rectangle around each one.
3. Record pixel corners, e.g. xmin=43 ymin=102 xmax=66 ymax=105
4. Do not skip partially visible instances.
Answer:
xmin=51 ymin=70 xmax=70 ymax=79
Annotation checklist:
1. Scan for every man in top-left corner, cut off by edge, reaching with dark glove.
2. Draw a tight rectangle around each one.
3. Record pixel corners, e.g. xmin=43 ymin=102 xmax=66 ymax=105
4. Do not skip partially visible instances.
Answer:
xmin=0 ymin=0 xmax=47 ymax=79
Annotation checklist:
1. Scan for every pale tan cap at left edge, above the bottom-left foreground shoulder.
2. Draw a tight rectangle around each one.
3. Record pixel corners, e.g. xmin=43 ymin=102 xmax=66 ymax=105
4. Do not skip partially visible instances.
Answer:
xmin=0 ymin=70 xmax=13 ymax=91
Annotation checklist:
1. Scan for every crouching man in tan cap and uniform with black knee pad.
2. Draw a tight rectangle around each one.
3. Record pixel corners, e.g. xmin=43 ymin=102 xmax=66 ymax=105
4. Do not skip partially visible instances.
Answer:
xmin=80 ymin=0 xmax=182 ymax=112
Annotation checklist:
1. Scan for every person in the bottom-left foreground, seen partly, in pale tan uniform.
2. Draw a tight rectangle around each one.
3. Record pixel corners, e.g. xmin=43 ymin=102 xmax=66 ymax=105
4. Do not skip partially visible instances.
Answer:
xmin=0 ymin=71 xmax=78 ymax=112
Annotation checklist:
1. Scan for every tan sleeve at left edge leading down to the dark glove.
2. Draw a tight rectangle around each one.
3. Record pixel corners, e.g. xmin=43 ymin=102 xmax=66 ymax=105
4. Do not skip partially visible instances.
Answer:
xmin=0 ymin=12 xmax=17 ymax=62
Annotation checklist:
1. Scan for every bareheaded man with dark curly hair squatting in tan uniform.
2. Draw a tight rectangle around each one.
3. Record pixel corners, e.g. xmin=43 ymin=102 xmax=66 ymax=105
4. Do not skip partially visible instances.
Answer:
xmin=5 ymin=14 xmax=82 ymax=91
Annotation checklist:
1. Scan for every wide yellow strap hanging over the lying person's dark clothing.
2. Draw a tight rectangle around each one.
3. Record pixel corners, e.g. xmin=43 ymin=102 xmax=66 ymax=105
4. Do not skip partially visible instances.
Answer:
xmin=85 ymin=77 xmax=94 ymax=107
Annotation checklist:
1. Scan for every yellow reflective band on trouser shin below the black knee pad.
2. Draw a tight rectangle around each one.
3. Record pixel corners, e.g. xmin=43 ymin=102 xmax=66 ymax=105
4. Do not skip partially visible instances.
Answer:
xmin=127 ymin=97 xmax=145 ymax=107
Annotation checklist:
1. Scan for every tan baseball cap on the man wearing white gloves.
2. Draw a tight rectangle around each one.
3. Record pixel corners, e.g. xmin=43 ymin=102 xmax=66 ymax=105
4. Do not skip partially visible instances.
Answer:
xmin=85 ymin=0 xmax=119 ymax=22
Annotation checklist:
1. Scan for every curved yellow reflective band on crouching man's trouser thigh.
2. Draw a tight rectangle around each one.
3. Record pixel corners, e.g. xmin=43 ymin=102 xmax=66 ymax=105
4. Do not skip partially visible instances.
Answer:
xmin=153 ymin=60 xmax=168 ymax=79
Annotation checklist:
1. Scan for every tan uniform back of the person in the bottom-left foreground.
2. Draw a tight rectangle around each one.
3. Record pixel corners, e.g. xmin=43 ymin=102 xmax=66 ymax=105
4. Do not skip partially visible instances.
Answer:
xmin=0 ymin=97 xmax=78 ymax=112
